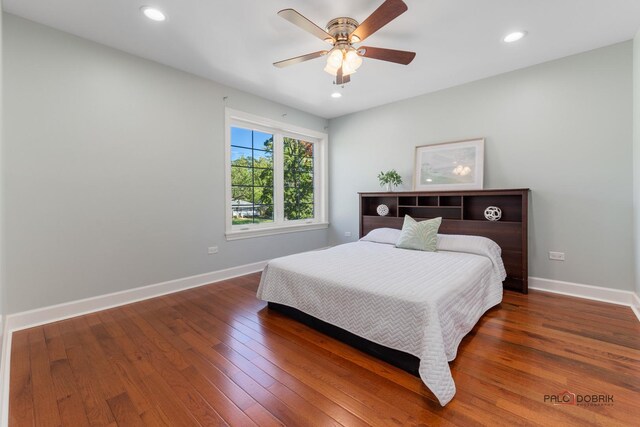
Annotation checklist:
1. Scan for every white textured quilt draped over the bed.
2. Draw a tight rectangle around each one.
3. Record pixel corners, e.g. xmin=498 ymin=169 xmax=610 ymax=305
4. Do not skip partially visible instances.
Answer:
xmin=257 ymin=236 xmax=506 ymax=406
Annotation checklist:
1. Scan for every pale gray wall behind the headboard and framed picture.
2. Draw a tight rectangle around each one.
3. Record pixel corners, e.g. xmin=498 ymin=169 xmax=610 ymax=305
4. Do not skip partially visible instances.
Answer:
xmin=329 ymin=42 xmax=634 ymax=290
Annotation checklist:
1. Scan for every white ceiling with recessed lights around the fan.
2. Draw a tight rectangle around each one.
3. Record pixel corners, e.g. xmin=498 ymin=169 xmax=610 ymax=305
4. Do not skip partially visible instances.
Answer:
xmin=3 ymin=0 xmax=640 ymax=118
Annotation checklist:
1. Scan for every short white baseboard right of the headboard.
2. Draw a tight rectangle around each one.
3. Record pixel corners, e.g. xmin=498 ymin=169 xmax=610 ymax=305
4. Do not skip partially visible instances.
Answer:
xmin=529 ymin=277 xmax=640 ymax=320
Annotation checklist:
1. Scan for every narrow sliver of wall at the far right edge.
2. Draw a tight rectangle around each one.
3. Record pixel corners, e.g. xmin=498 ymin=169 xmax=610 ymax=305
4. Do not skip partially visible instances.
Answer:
xmin=633 ymin=31 xmax=640 ymax=295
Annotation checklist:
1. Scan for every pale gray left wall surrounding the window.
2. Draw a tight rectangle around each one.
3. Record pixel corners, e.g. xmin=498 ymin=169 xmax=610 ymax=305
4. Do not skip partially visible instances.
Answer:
xmin=2 ymin=15 xmax=327 ymax=313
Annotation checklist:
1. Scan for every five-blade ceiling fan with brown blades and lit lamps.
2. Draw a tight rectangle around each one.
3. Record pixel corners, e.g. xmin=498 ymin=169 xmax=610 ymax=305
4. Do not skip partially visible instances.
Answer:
xmin=273 ymin=0 xmax=416 ymax=85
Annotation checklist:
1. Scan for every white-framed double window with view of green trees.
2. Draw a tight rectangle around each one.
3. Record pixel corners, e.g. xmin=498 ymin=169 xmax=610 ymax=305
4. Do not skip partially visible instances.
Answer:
xmin=226 ymin=109 xmax=328 ymax=240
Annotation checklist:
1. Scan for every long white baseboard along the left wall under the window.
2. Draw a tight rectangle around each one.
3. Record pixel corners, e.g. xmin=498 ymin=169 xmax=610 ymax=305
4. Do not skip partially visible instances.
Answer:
xmin=6 ymin=261 xmax=267 ymax=333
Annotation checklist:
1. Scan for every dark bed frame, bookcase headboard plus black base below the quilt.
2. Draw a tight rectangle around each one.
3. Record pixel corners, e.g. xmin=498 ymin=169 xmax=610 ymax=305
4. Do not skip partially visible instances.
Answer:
xmin=268 ymin=189 xmax=529 ymax=376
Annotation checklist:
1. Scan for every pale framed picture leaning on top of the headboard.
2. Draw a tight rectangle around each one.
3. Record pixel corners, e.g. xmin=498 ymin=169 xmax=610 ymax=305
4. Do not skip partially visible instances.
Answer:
xmin=413 ymin=138 xmax=484 ymax=191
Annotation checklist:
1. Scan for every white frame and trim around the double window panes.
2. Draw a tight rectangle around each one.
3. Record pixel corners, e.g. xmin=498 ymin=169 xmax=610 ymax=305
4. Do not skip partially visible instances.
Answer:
xmin=225 ymin=108 xmax=329 ymax=240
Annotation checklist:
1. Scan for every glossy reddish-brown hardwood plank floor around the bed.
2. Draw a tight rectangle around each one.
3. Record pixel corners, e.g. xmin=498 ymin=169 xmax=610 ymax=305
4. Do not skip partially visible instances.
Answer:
xmin=9 ymin=274 xmax=640 ymax=427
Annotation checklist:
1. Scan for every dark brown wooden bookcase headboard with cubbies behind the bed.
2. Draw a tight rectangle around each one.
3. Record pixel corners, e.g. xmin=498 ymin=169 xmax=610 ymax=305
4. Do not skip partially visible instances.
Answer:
xmin=359 ymin=188 xmax=529 ymax=294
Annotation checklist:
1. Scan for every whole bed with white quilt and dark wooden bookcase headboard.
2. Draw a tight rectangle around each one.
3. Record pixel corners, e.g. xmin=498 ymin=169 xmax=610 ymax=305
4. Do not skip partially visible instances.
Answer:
xmin=257 ymin=189 xmax=529 ymax=406
